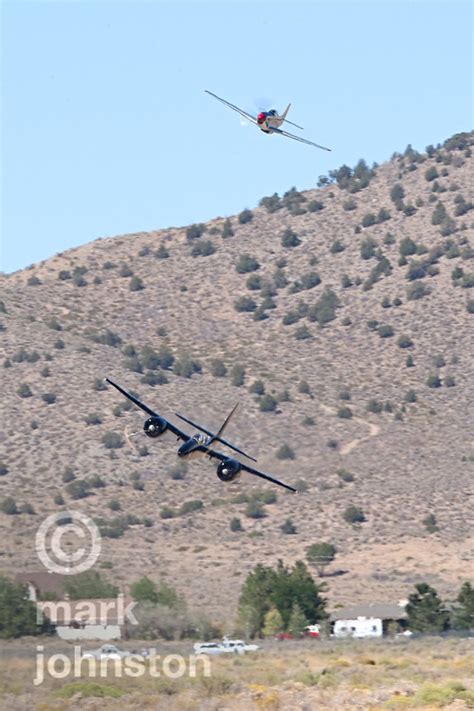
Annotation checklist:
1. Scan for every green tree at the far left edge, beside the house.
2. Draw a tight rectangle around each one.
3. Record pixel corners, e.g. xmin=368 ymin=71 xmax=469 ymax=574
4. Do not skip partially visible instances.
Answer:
xmin=0 ymin=575 xmax=52 ymax=639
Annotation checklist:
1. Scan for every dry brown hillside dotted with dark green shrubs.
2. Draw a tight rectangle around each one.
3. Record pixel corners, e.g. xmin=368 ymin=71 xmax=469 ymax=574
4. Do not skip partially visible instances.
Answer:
xmin=0 ymin=135 xmax=474 ymax=616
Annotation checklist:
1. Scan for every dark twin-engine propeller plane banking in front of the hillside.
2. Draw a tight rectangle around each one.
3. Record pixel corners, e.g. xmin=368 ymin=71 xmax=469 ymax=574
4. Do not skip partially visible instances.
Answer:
xmin=105 ymin=378 xmax=296 ymax=493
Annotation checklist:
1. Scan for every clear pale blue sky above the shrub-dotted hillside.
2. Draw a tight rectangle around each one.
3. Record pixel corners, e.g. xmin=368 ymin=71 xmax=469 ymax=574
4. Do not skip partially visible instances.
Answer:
xmin=0 ymin=0 xmax=473 ymax=272
